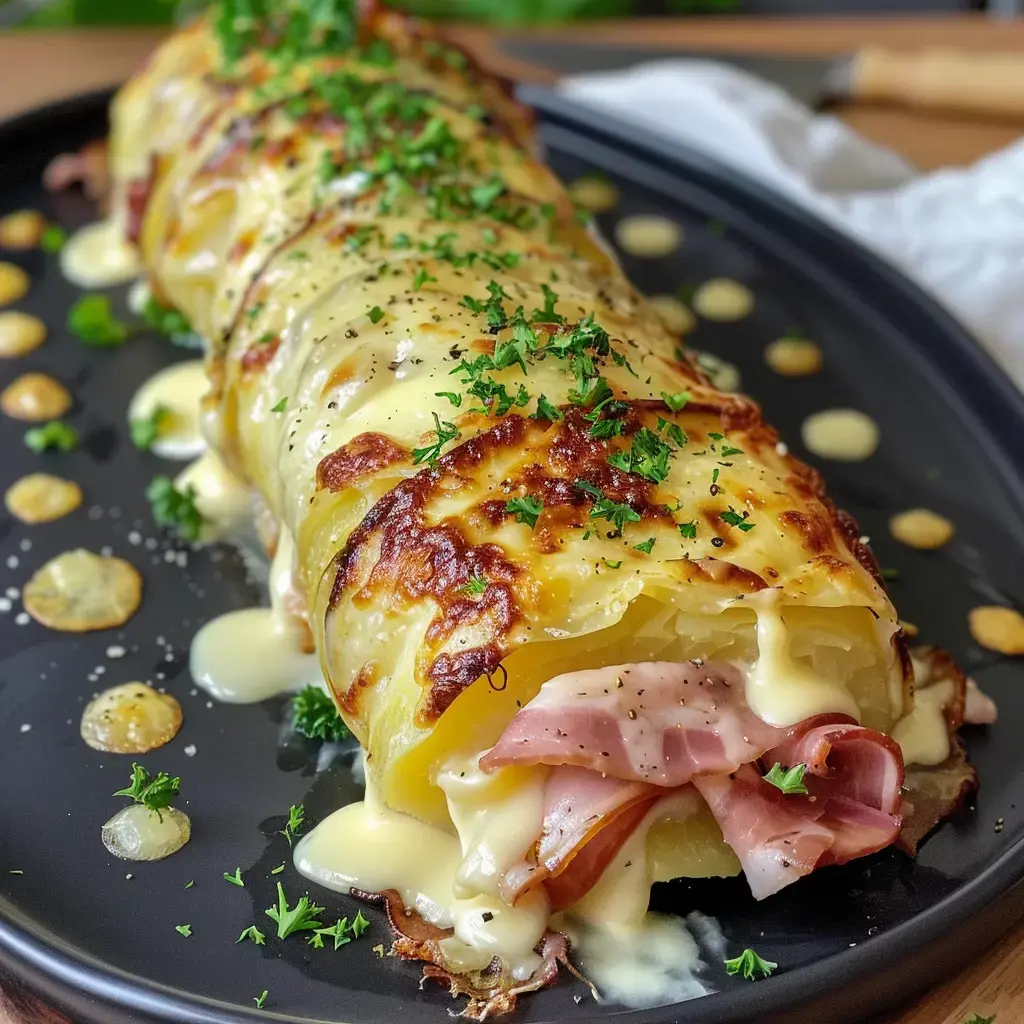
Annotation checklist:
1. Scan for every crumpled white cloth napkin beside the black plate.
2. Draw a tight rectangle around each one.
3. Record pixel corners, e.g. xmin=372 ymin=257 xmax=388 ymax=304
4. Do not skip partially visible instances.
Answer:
xmin=561 ymin=60 xmax=1024 ymax=388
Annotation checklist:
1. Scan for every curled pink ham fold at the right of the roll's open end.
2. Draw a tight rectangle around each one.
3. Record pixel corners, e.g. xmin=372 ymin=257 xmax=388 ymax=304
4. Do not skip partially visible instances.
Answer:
xmin=693 ymin=716 xmax=903 ymax=899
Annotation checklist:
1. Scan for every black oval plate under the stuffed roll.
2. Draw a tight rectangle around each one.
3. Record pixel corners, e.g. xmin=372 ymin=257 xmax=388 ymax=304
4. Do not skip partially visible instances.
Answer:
xmin=0 ymin=86 xmax=1024 ymax=1024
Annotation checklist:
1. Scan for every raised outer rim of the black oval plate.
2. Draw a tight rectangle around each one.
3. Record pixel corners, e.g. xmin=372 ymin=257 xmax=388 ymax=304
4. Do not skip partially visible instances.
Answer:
xmin=0 ymin=86 xmax=1024 ymax=1024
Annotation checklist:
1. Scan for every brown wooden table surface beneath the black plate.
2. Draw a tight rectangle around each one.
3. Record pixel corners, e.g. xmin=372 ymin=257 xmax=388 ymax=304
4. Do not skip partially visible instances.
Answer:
xmin=0 ymin=15 xmax=1024 ymax=1024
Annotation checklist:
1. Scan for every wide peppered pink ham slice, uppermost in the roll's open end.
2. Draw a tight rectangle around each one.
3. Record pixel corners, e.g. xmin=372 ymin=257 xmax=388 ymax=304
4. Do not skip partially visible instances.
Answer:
xmin=480 ymin=662 xmax=782 ymax=787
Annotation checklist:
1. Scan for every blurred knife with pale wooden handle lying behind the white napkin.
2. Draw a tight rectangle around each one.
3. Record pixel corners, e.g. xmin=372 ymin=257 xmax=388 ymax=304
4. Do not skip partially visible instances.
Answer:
xmin=498 ymin=36 xmax=1024 ymax=120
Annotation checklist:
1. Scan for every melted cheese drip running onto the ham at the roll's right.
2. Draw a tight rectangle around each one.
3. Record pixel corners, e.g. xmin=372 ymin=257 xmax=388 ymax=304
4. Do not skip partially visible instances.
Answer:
xmin=745 ymin=590 xmax=860 ymax=728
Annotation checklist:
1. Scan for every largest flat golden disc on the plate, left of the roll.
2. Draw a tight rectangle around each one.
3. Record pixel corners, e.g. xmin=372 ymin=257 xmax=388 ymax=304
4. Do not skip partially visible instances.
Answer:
xmin=22 ymin=548 xmax=142 ymax=633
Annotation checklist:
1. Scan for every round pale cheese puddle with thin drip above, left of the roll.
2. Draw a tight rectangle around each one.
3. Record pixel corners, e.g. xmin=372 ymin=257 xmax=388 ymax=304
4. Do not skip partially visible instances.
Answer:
xmin=189 ymin=532 xmax=322 ymax=703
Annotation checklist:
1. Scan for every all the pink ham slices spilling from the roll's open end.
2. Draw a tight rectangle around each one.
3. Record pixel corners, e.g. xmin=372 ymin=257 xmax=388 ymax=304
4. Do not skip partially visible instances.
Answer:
xmin=480 ymin=663 xmax=903 ymax=909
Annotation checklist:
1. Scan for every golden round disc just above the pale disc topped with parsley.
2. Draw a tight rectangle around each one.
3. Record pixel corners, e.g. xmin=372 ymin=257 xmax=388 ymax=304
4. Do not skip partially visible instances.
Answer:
xmin=81 ymin=683 xmax=181 ymax=754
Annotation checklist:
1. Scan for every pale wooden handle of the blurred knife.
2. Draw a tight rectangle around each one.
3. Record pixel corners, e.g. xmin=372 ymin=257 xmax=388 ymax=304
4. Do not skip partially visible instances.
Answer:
xmin=850 ymin=46 xmax=1024 ymax=119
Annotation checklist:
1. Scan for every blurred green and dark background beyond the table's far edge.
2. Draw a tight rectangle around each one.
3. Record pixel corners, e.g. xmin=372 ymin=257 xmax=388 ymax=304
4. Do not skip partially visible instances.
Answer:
xmin=0 ymin=0 xmax=1024 ymax=26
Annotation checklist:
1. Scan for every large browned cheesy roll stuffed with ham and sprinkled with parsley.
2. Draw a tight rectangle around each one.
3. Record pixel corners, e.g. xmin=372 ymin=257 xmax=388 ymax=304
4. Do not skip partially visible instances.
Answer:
xmin=101 ymin=0 xmax=973 ymax=1017
